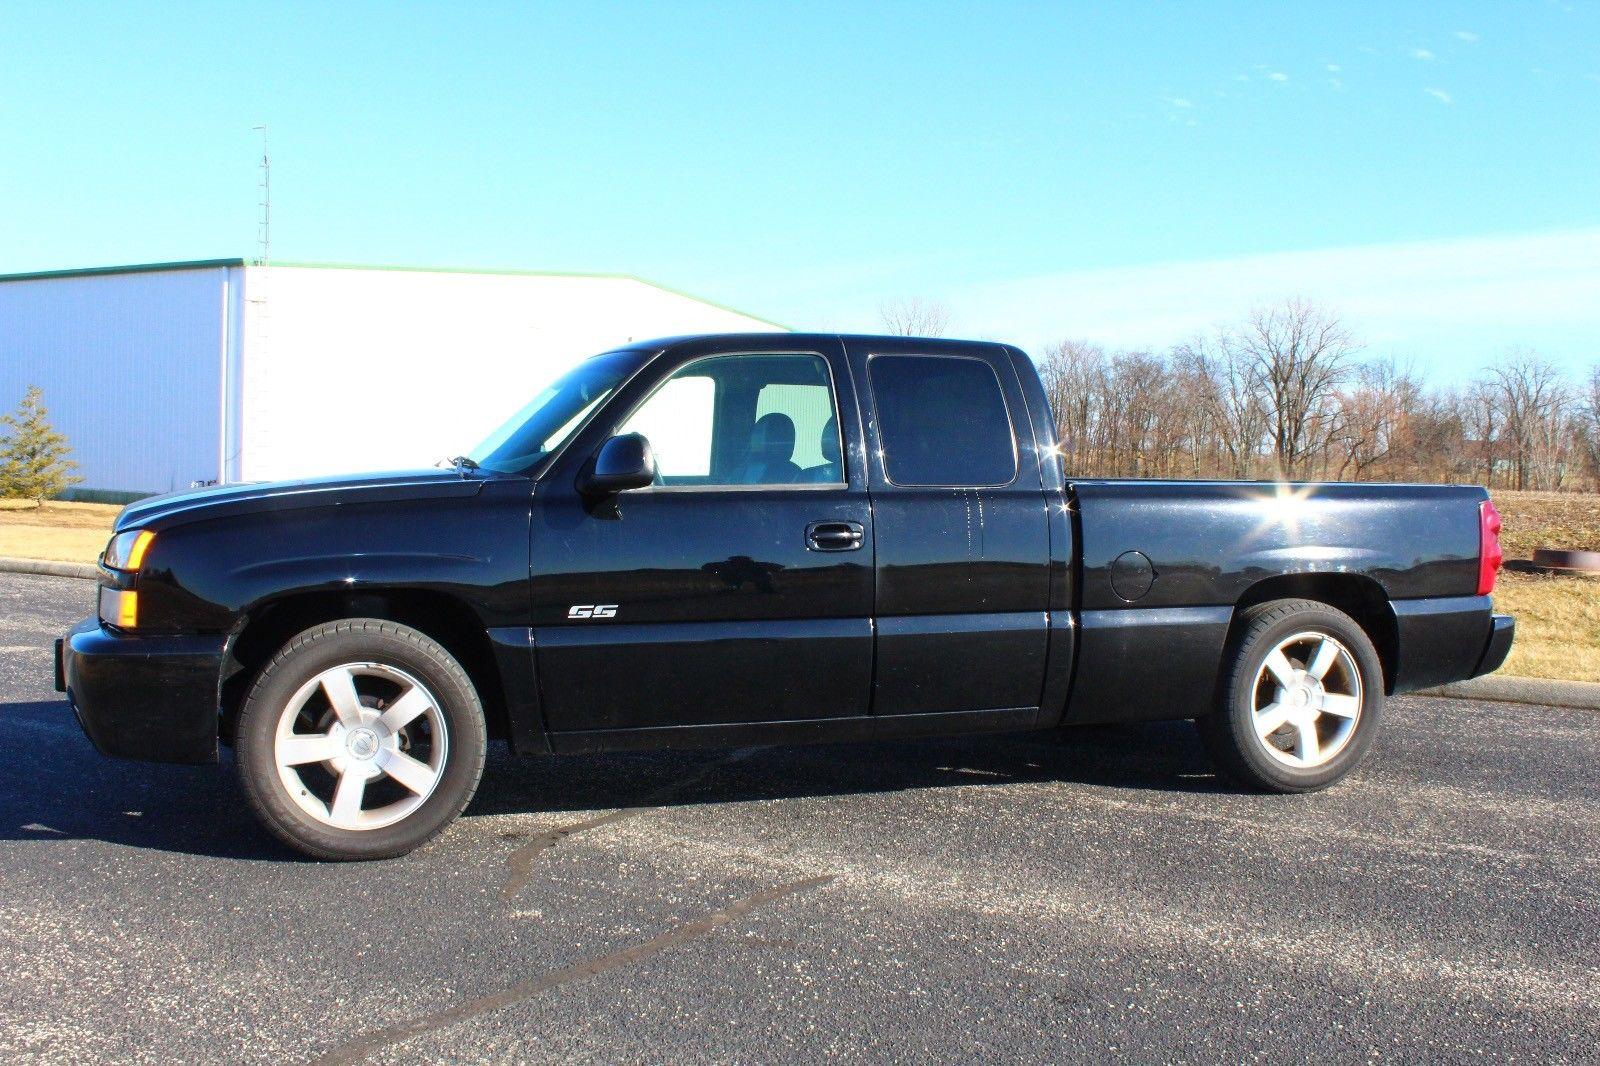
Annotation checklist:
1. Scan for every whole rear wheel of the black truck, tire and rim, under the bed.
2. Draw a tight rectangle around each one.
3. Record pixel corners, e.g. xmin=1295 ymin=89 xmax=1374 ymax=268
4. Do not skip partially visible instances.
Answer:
xmin=1198 ymin=600 xmax=1384 ymax=792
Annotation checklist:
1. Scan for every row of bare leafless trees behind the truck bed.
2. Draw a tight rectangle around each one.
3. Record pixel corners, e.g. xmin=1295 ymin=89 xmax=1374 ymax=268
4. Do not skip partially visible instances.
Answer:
xmin=883 ymin=299 xmax=1600 ymax=490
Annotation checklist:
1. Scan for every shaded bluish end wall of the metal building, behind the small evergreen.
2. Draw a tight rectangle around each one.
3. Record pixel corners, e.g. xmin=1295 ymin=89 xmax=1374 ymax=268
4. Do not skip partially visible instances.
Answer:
xmin=0 ymin=267 xmax=225 ymax=493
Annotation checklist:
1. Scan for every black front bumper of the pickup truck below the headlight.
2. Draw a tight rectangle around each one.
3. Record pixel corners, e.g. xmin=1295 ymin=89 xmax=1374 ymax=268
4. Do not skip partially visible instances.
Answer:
xmin=56 ymin=618 xmax=226 ymax=762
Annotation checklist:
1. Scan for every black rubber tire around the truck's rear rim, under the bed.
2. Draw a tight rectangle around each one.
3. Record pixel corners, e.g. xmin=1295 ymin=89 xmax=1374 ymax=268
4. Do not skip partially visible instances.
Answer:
xmin=1197 ymin=600 xmax=1384 ymax=792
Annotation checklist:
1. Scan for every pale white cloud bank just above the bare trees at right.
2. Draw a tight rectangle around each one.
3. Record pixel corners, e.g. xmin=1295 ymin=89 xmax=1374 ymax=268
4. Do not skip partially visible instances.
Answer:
xmin=934 ymin=227 xmax=1600 ymax=381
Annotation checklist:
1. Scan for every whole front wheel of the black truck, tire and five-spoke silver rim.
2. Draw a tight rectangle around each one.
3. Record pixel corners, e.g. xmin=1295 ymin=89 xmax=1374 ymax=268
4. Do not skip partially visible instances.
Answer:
xmin=235 ymin=618 xmax=486 ymax=860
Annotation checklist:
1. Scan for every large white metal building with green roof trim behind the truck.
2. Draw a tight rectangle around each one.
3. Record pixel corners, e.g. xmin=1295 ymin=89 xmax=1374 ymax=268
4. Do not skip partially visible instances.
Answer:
xmin=0 ymin=261 xmax=779 ymax=493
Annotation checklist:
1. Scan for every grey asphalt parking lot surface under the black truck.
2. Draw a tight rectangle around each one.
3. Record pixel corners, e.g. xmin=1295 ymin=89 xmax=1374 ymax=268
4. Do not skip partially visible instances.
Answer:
xmin=0 ymin=575 xmax=1600 ymax=1063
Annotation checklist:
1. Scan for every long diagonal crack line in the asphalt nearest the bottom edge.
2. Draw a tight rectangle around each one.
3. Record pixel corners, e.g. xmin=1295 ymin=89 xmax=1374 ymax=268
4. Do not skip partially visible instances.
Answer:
xmin=312 ymin=874 xmax=835 ymax=1066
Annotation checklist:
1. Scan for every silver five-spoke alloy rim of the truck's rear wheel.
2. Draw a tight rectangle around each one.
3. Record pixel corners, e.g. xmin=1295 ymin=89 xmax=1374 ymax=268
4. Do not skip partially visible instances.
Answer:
xmin=1251 ymin=632 xmax=1362 ymax=770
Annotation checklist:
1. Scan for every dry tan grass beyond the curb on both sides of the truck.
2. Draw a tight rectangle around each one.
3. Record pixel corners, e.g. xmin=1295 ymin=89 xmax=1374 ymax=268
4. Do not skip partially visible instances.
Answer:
xmin=0 ymin=491 xmax=1600 ymax=682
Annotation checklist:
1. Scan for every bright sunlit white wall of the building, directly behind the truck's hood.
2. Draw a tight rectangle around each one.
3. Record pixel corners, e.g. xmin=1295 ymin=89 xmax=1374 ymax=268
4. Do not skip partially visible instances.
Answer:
xmin=238 ymin=266 xmax=778 ymax=480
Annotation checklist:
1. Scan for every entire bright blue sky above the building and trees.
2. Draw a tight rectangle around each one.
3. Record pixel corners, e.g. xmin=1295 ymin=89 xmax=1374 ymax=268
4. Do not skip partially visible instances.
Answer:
xmin=0 ymin=0 xmax=1600 ymax=379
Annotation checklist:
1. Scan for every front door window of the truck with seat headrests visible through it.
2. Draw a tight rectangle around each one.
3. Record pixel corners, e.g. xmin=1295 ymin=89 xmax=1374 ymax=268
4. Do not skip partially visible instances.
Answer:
xmin=618 ymin=354 xmax=845 ymax=487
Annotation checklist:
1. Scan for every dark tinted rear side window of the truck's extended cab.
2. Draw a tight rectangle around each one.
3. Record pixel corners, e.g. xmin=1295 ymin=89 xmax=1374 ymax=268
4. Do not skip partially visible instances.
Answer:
xmin=867 ymin=355 xmax=1016 ymax=485
